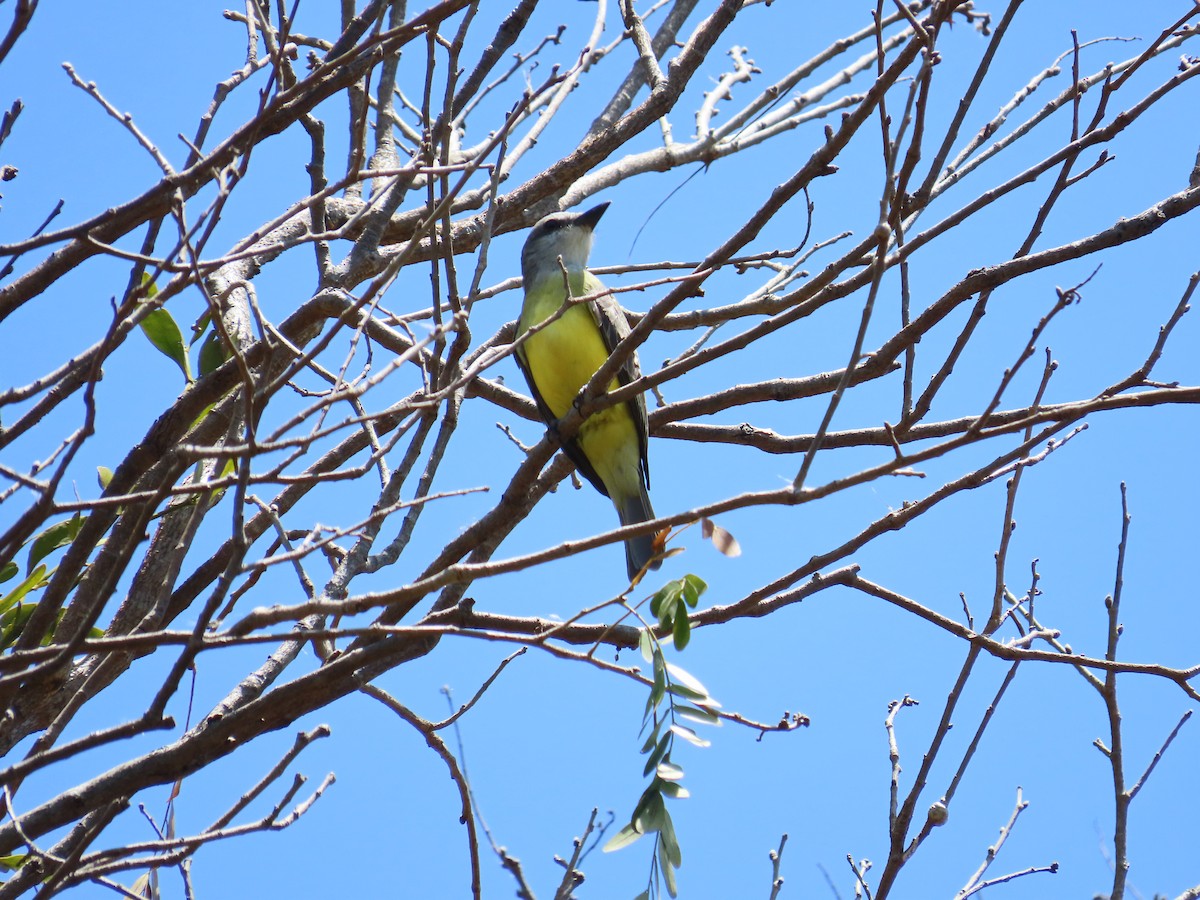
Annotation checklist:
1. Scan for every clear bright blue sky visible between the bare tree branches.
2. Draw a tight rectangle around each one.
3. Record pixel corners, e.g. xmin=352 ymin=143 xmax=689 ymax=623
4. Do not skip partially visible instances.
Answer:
xmin=0 ymin=1 xmax=1200 ymax=898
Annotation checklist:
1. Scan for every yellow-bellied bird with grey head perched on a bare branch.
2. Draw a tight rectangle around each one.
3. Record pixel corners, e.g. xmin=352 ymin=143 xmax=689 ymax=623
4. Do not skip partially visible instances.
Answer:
xmin=515 ymin=203 xmax=661 ymax=581
